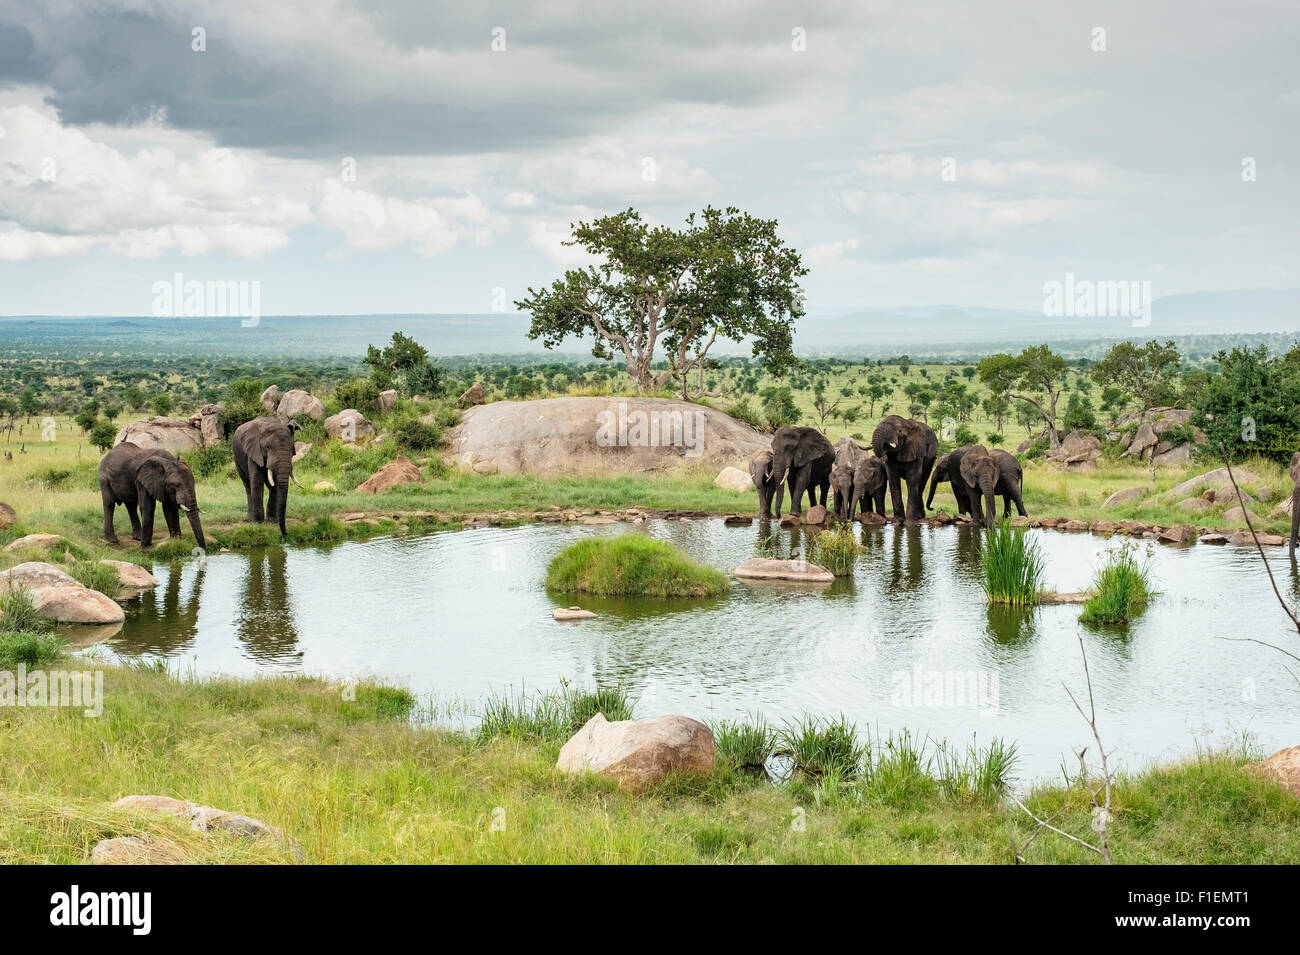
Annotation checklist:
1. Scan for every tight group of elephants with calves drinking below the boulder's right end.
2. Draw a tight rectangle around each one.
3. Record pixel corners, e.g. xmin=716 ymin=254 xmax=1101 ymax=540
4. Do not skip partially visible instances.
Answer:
xmin=749 ymin=414 xmax=1027 ymax=526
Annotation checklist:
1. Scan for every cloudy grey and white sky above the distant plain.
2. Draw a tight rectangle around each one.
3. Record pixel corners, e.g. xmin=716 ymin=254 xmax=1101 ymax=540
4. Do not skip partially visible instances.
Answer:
xmin=0 ymin=0 xmax=1300 ymax=314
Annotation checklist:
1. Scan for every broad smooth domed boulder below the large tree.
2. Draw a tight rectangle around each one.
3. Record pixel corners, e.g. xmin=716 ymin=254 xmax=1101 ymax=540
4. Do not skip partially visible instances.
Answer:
xmin=449 ymin=398 xmax=771 ymax=476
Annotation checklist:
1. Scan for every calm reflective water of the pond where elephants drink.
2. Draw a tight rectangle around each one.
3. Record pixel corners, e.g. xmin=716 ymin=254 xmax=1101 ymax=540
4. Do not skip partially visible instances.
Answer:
xmin=101 ymin=520 xmax=1300 ymax=780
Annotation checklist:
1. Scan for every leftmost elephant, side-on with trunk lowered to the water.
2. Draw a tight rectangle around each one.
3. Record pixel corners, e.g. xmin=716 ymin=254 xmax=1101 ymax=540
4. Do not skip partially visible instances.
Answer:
xmin=99 ymin=440 xmax=208 ymax=551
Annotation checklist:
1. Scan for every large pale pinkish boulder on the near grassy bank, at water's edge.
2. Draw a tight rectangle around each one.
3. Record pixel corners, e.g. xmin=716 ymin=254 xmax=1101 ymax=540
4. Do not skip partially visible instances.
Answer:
xmin=555 ymin=713 xmax=716 ymax=794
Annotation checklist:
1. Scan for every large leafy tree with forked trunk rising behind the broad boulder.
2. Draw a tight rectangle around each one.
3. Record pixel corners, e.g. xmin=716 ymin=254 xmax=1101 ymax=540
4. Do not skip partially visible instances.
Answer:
xmin=515 ymin=207 xmax=807 ymax=398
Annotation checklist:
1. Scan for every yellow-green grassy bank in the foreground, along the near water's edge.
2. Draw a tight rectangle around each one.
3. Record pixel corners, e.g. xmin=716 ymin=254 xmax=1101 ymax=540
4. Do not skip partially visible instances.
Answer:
xmin=0 ymin=663 xmax=1300 ymax=863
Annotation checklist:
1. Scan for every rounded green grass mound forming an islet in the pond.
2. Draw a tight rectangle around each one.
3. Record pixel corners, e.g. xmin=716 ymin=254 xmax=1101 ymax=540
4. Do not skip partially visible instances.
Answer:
xmin=546 ymin=533 xmax=731 ymax=598
